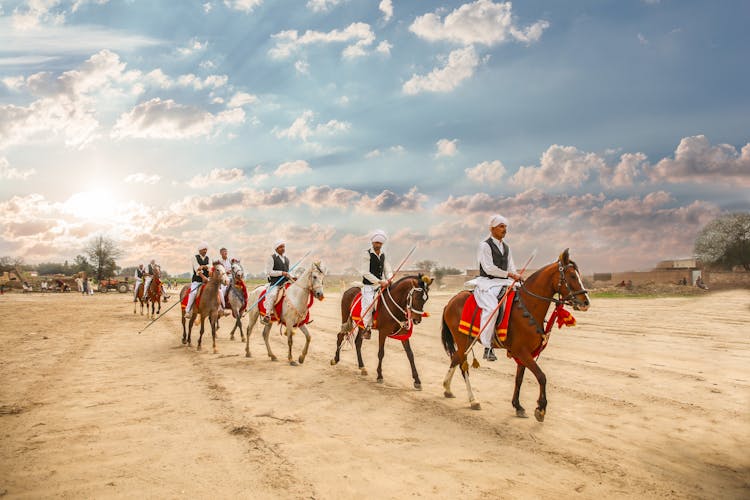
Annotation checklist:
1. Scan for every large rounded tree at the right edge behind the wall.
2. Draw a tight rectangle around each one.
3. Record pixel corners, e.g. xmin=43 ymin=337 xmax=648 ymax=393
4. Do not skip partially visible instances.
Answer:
xmin=694 ymin=212 xmax=750 ymax=271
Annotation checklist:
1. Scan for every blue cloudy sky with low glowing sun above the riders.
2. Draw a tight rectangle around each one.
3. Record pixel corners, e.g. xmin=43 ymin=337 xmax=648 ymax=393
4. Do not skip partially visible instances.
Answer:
xmin=0 ymin=0 xmax=750 ymax=274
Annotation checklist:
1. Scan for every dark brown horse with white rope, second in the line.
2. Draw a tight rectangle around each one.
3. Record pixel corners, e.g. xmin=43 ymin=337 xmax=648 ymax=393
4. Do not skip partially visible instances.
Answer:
xmin=331 ymin=274 xmax=433 ymax=390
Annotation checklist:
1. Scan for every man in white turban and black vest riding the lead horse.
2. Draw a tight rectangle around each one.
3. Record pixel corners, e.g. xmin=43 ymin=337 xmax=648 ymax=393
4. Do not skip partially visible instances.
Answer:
xmin=471 ymin=215 xmax=521 ymax=361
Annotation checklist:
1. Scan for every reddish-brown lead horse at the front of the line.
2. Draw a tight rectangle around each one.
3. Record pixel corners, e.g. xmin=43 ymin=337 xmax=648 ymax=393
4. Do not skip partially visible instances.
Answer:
xmin=442 ymin=249 xmax=590 ymax=422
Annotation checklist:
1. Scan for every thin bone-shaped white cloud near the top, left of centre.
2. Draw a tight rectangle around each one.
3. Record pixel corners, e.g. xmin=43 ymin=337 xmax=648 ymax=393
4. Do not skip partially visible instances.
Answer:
xmin=268 ymin=23 xmax=375 ymax=60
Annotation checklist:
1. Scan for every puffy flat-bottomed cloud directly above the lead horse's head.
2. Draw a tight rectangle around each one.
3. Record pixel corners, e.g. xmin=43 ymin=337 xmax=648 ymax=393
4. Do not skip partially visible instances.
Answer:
xmin=511 ymin=144 xmax=606 ymax=187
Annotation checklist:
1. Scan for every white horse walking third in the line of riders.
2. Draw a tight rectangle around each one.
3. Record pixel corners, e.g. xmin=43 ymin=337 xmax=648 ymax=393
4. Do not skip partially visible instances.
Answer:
xmin=245 ymin=261 xmax=325 ymax=366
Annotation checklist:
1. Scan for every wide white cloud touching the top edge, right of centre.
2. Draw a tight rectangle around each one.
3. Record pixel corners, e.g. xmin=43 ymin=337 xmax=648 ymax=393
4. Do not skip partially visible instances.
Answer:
xmin=409 ymin=0 xmax=549 ymax=47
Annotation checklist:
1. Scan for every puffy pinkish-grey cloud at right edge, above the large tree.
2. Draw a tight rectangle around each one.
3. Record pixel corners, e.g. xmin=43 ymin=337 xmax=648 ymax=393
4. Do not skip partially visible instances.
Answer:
xmin=650 ymin=135 xmax=750 ymax=186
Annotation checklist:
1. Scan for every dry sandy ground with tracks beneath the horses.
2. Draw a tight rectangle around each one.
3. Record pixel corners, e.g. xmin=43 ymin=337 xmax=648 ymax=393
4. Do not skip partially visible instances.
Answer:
xmin=0 ymin=291 xmax=750 ymax=499
